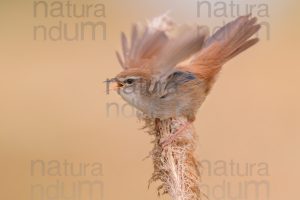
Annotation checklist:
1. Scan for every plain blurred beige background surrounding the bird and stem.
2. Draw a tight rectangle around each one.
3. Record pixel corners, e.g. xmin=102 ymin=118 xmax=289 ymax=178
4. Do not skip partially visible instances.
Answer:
xmin=0 ymin=0 xmax=300 ymax=200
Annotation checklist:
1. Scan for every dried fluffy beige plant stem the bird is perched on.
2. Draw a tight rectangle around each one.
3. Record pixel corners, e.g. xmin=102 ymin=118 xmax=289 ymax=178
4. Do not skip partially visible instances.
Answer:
xmin=145 ymin=118 xmax=201 ymax=200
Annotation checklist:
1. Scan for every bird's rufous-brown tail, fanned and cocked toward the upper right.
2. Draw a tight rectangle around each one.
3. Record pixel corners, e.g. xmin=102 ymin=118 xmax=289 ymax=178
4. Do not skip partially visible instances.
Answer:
xmin=178 ymin=15 xmax=260 ymax=79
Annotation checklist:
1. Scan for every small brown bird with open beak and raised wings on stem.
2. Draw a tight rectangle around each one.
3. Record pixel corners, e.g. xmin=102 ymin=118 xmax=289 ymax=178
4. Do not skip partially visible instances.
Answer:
xmin=110 ymin=14 xmax=261 ymax=146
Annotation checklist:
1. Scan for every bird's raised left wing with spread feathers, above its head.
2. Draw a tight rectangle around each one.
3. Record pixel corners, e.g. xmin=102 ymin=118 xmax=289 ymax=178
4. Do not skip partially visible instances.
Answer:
xmin=116 ymin=15 xmax=173 ymax=70
